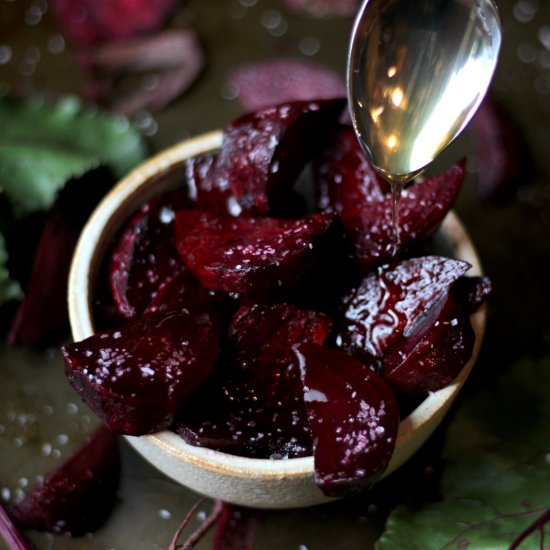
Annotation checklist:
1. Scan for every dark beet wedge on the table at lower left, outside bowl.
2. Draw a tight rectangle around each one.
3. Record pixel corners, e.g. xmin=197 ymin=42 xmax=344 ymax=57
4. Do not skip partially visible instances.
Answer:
xmin=13 ymin=427 xmax=120 ymax=536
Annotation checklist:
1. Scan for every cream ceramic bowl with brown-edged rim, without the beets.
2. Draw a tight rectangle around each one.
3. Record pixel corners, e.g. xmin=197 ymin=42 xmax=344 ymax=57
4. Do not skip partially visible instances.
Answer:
xmin=68 ymin=131 xmax=486 ymax=508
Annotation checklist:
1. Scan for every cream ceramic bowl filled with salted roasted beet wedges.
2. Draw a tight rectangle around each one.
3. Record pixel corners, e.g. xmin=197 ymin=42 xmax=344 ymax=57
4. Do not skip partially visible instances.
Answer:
xmin=63 ymin=99 xmax=491 ymax=508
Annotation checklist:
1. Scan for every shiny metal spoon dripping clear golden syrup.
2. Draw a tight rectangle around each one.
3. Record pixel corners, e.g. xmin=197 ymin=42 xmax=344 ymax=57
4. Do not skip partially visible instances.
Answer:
xmin=347 ymin=0 xmax=502 ymax=188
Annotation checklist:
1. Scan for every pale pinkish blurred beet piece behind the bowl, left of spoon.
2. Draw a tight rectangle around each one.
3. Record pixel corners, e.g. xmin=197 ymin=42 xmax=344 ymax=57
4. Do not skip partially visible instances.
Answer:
xmin=229 ymin=58 xmax=346 ymax=111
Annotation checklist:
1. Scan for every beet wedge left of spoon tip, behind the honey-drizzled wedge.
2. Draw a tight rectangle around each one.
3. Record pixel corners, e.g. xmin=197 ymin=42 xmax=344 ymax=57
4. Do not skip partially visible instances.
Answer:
xmin=313 ymin=125 xmax=390 ymax=213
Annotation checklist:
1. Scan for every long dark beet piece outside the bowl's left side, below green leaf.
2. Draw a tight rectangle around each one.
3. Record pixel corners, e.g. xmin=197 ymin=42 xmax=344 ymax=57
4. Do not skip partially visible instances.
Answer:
xmin=7 ymin=168 xmax=114 ymax=346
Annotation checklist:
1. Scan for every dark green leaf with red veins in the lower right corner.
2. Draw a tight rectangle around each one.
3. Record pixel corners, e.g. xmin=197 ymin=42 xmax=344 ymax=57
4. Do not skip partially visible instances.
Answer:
xmin=377 ymin=358 xmax=550 ymax=550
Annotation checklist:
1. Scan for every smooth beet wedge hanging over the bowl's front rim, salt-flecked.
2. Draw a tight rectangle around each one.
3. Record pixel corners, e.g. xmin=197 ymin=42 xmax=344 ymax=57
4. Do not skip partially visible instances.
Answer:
xmin=296 ymin=344 xmax=399 ymax=497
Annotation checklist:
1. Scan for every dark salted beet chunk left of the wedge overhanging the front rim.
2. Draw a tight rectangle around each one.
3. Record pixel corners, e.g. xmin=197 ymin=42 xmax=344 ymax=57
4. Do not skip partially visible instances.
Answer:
xmin=178 ymin=304 xmax=332 ymax=458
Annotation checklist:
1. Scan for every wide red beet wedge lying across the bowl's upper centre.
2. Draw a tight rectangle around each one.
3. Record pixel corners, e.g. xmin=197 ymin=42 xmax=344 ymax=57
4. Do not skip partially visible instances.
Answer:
xmin=175 ymin=210 xmax=334 ymax=302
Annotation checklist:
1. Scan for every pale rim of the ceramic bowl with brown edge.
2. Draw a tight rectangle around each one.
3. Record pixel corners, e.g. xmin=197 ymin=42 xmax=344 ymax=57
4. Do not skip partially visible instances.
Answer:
xmin=68 ymin=130 xmax=486 ymax=479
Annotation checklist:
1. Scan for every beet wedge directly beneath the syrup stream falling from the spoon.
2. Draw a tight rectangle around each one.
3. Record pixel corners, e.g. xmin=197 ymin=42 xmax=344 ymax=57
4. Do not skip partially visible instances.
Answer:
xmin=341 ymin=162 xmax=465 ymax=273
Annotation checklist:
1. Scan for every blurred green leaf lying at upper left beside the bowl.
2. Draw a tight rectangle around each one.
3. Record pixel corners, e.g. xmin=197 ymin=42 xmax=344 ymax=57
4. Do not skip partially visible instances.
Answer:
xmin=0 ymin=90 xmax=146 ymax=214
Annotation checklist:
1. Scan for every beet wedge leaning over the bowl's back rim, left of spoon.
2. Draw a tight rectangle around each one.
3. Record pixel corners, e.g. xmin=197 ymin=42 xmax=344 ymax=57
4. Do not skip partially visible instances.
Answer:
xmin=214 ymin=99 xmax=346 ymax=214
